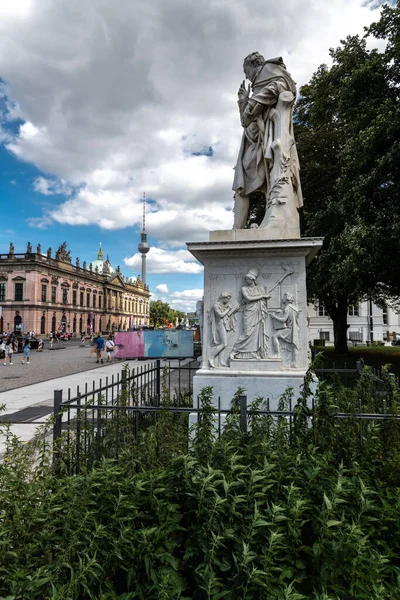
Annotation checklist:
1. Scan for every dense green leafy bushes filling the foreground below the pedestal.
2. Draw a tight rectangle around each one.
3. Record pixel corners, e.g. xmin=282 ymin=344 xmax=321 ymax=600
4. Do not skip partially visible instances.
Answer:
xmin=0 ymin=370 xmax=400 ymax=600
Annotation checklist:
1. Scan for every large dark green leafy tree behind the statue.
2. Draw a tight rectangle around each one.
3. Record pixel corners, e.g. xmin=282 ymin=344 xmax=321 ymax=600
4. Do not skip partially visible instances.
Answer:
xmin=295 ymin=6 xmax=400 ymax=352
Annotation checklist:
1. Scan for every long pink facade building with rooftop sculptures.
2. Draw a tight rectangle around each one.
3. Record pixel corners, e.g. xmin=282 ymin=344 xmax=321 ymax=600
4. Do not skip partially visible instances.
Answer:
xmin=0 ymin=243 xmax=150 ymax=335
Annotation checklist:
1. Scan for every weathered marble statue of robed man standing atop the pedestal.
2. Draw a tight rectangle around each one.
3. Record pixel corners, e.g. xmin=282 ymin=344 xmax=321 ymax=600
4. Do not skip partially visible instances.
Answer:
xmin=232 ymin=52 xmax=303 ymax=233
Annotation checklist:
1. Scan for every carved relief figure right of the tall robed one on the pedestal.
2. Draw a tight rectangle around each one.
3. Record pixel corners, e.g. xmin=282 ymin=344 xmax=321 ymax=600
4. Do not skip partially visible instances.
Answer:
xmin=271 ymin=293 xmax=300 ymax=367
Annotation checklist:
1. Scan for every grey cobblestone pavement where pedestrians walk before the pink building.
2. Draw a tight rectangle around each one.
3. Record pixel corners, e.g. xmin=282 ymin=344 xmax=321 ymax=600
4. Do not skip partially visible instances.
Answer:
xmin=0 ymin=340 xmax=130 ymax=392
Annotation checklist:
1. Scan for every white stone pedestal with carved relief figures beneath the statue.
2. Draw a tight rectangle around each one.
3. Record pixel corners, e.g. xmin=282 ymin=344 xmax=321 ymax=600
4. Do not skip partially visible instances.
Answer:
xmin=188 ymin=229 xmax=323 ymax=410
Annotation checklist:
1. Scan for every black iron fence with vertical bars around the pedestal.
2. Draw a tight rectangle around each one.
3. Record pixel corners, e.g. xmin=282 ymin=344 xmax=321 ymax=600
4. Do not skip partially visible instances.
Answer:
xmin=49 ymin=360 xmax=400 ymax=474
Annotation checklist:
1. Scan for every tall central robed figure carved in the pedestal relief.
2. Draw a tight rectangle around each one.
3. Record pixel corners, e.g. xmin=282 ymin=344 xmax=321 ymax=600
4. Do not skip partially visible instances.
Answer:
xmin=231 ymin=268 xmax=271 ymax=359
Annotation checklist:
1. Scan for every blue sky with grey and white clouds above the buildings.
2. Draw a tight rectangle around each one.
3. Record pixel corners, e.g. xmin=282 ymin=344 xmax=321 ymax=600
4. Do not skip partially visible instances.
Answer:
xmin=0 ymin=0 xmax=384 ymax=310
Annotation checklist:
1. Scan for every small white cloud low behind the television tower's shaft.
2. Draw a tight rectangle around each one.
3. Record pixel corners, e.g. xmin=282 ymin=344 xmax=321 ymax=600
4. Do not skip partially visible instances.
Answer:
xmin=124 ymin=247 xmax=203 ymax=274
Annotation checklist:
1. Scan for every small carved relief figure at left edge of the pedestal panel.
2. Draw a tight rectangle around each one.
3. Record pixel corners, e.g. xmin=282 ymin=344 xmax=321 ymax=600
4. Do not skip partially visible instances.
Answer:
xmin=208 ymin=292 xmax=236 ymax=368
